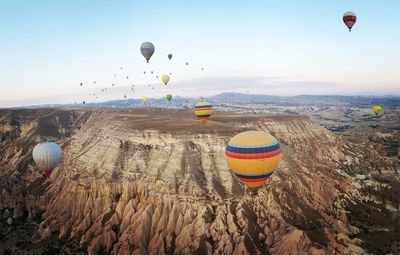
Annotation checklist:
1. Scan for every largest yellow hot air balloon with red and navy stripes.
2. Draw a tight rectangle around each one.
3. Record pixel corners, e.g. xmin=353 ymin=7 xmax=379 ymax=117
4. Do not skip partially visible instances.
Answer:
xmin=225 ymin=131 xmax=281 ymax=191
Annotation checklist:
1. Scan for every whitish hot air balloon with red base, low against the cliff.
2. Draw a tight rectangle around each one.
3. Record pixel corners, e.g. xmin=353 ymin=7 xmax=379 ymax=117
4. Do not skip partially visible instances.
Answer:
xmin=32 ymin=142 xmax=62 ymax=177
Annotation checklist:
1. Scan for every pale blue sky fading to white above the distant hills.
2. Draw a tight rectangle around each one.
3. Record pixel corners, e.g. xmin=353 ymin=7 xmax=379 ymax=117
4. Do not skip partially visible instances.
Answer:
xmin=0 ymin=0 xmax=400 ymax=107
